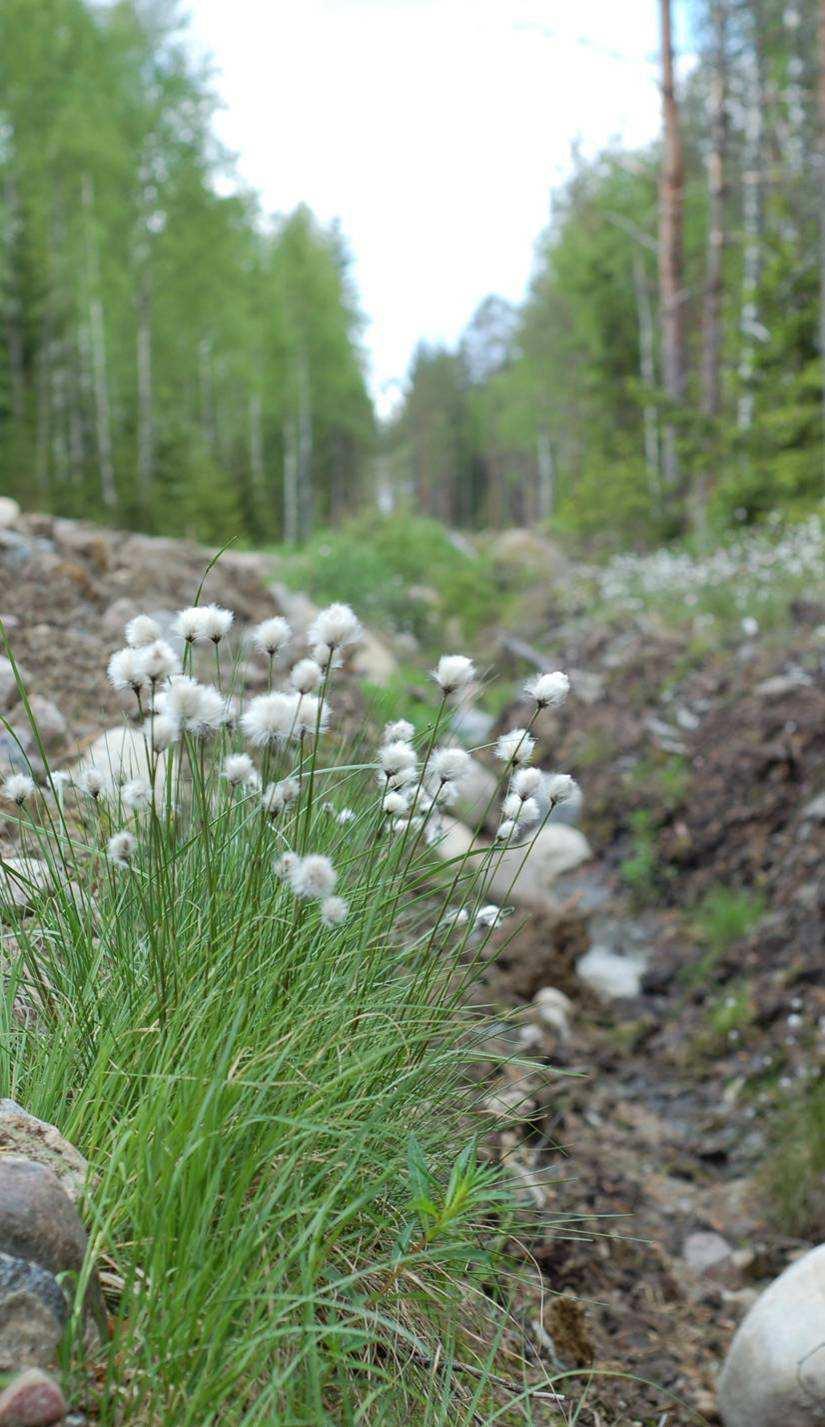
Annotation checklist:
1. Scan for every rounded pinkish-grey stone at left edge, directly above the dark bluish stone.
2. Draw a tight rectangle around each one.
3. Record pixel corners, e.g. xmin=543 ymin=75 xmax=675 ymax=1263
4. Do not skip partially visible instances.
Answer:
xmin=0 ymin=1154 xmax=87 ymax=1274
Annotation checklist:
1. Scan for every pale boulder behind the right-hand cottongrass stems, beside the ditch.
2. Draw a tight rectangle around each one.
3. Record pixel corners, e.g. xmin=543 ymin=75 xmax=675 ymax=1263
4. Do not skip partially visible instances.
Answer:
xmin=435 ymin=819 xmax=591 ymax=913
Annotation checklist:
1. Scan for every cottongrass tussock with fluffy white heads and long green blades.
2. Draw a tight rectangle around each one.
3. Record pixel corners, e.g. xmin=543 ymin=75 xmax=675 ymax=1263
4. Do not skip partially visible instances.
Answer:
xmin=0 ymin=604 xmax=570 ymax=1427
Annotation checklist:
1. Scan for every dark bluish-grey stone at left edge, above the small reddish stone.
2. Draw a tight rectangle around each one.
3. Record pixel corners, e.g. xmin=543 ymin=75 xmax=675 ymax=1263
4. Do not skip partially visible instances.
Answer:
xmin=0 ymin=1253 xmax=69 ymax=1369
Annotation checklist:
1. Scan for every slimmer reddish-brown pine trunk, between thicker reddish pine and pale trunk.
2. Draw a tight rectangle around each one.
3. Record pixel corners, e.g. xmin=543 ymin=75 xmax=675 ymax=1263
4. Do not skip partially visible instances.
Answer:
xmin=694 ymin=0 xmax=728 ymax=529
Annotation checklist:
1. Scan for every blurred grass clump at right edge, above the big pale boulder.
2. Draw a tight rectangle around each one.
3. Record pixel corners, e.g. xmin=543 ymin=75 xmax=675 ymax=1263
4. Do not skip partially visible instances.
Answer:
xmin=762 ymin=1085 xmax=825 ymax=1237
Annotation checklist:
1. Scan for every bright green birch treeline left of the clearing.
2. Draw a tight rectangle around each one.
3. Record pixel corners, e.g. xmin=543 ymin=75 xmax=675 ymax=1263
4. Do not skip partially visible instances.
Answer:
xmin=0 ymin=0 xmax=373 ymax=541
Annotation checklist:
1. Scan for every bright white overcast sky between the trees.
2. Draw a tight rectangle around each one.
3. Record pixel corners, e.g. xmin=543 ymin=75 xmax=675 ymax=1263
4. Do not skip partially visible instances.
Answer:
xmin=182 ymin=0 xmax=658 ymax=411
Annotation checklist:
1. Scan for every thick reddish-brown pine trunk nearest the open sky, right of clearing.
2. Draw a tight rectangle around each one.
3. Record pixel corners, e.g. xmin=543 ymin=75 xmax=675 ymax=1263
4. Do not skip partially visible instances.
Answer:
xmin=659 ymin=0 xmax=685 ymax=495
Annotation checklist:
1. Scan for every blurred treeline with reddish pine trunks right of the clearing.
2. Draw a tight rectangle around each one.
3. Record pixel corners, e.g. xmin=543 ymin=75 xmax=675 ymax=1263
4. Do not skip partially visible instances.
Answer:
xmin=388 ymin=0 xmax=825 ymax=542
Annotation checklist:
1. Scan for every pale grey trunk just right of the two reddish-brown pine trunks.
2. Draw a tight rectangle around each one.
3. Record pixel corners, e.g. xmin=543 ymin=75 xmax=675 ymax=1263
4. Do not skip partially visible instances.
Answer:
xmin=737 ymin=8 xmax=765 ymax=431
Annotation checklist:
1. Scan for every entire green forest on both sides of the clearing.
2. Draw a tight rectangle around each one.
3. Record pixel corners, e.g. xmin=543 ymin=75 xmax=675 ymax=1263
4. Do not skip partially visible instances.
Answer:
xmin=0 ymin=0 xmax=825 ymax=547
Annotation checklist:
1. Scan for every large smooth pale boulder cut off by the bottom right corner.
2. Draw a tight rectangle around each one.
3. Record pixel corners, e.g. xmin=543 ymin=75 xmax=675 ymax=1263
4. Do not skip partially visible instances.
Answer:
xmin=718 ymin=1244 xmax=825 ymax=1427
